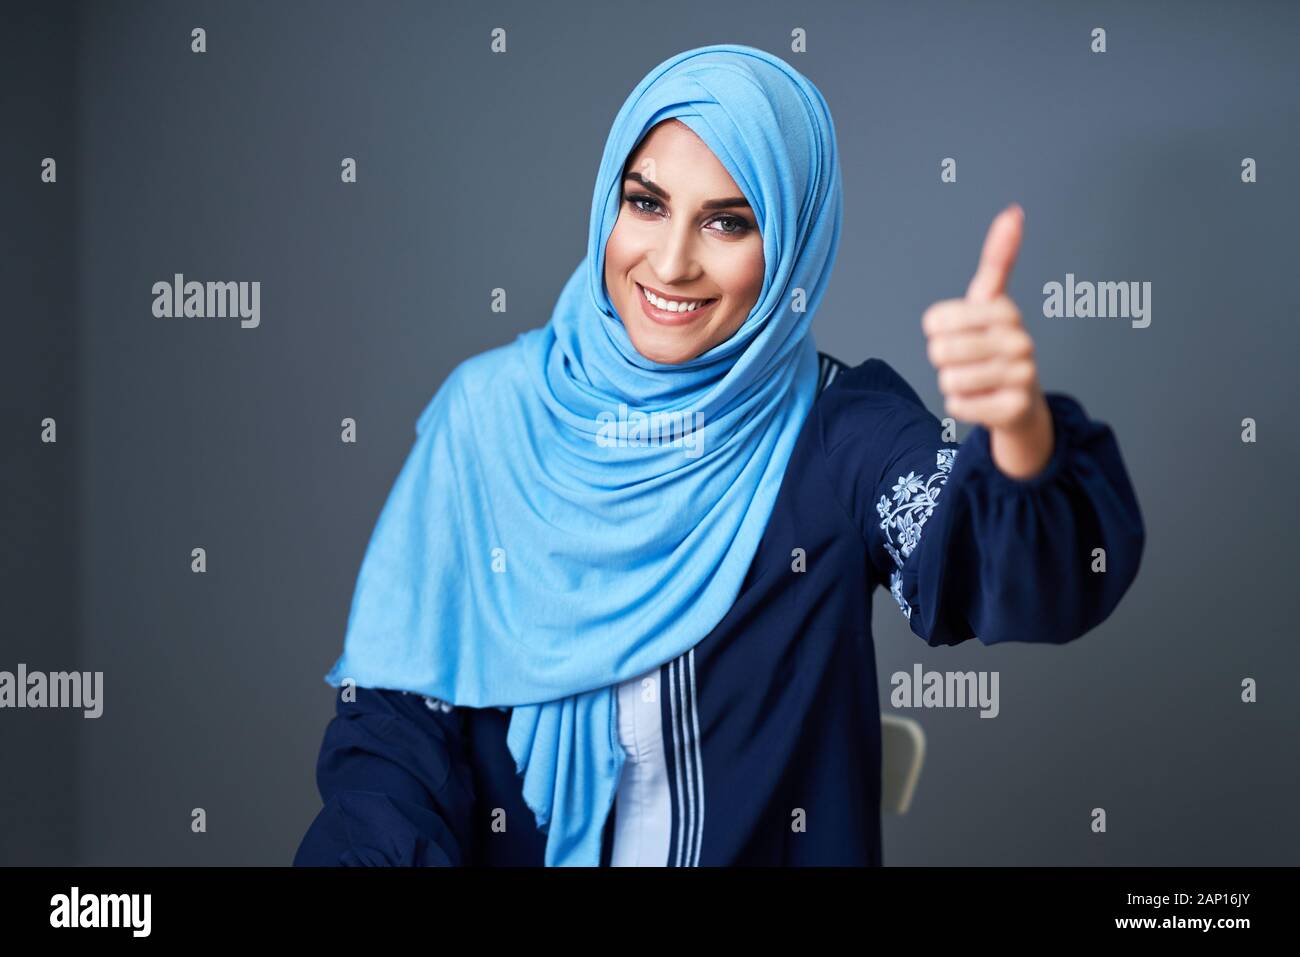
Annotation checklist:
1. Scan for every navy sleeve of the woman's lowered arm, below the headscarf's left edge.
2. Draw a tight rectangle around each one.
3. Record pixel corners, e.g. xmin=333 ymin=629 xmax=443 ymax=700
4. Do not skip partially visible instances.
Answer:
xmin=294 ymin=688 xmax=475 ymax=867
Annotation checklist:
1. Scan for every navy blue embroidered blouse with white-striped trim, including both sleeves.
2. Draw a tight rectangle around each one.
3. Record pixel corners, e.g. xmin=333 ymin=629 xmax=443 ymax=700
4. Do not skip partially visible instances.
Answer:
xmin=294 ymin=356 xmax=1145 ymax=866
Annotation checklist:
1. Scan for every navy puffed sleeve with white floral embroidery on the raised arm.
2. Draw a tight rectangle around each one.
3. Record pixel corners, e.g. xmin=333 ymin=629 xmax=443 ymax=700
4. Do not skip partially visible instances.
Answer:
xmin=824 ymin=360 xmax=1145 ymax=645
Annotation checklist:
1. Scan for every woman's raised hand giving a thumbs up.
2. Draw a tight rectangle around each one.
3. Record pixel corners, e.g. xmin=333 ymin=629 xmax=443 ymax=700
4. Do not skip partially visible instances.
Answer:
xmin=920 ymin=204 xmax=1053 ymax=479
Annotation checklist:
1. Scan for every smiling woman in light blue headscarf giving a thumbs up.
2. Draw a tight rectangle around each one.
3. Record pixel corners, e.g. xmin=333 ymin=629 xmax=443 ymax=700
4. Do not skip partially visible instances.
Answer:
xmin=295 ymin=44 xmax=1143 ymax=865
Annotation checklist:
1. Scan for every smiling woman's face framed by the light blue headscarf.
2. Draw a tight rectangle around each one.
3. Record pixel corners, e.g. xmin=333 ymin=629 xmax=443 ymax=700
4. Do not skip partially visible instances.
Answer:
xmin=605 ymin=120 xmax=763 ymax=364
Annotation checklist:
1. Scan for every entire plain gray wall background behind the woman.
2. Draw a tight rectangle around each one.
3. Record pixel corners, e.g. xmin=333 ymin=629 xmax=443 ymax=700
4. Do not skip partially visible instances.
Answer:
xmin=0 ymin=0 xmax=1300 ymax=865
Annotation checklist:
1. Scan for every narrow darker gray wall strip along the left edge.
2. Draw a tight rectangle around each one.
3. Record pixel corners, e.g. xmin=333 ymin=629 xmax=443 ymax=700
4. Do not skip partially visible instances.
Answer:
xmin=0 ymin=3 xmax=86 ymax=865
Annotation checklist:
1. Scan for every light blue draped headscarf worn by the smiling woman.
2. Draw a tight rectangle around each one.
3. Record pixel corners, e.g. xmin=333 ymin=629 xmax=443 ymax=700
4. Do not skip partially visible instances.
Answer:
xmin=325 ymin=44 xmax=841 ymax=865
